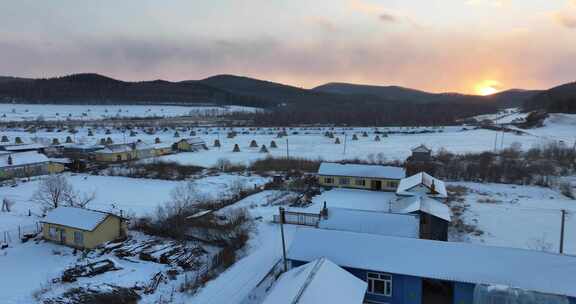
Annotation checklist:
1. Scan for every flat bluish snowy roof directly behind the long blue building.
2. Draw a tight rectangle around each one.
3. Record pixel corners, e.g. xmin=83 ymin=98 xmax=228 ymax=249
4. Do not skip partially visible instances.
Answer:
xmin=318 ymin=208 xmax=420 ymax=238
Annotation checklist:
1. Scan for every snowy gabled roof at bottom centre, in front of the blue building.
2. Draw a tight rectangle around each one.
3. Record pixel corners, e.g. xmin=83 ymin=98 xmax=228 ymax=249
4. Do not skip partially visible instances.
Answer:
xmin=262 ymin=258 xmax=367 ymax=304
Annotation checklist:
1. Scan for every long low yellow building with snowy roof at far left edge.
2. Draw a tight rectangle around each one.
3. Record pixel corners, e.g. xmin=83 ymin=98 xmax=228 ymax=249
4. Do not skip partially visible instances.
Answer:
xmin=0 ymin=151 xmax=65 ymax=179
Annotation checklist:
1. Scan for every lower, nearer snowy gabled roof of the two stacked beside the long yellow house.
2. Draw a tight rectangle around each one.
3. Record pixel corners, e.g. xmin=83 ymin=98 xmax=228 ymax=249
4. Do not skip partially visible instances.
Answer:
xmin=391 ymin=195 xmax=452 ymax=222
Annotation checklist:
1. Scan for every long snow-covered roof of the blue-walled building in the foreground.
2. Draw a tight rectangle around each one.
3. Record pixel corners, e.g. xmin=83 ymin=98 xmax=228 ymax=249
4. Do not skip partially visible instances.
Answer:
xmin=288 ymin=228 xmax=576 ymax=297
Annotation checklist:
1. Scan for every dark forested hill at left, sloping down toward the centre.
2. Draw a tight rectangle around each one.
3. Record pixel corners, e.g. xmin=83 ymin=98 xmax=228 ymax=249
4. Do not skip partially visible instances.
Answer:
xmin=0 ymin=73 xmax=267 ymax=107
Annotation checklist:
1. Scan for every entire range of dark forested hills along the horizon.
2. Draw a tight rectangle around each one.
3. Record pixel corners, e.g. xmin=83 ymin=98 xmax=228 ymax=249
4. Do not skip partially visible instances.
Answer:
xmin=0 ymin=73 xmax=574 ymax=113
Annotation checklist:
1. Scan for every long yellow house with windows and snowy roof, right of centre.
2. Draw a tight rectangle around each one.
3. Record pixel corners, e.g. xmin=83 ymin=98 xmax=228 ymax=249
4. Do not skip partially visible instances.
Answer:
xmin=318 ymin=162 xmax=406 ymax=191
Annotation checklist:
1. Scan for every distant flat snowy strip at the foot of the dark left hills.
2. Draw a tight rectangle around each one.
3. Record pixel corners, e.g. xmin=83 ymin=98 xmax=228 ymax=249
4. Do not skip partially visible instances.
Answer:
xmin=0 ymin=103 xmax=258 ymax=122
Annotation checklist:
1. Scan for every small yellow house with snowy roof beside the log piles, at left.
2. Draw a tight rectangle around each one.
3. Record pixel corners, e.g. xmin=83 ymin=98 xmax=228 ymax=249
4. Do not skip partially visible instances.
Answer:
xmin=41 ymin=207 xmax=126 ymax=249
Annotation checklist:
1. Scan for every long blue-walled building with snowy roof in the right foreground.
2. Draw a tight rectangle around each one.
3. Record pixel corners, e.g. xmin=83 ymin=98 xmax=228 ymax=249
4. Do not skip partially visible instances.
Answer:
xmin=287 ymin=229 xmax=576 ymax=304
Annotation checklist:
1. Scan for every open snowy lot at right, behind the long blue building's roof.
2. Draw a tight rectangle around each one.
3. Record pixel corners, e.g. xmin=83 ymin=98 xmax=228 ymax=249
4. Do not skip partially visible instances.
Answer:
xmin=449 ymin=182 xmax=576 ymax=254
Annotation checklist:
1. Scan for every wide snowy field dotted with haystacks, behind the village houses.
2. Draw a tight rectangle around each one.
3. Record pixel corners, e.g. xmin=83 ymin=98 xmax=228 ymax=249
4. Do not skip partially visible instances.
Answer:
xmin=0 ymin=114 xmax=576 ymax=167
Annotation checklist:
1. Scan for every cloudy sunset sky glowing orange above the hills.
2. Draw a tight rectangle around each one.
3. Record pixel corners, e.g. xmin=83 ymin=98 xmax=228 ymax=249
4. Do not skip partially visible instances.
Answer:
xmin=0 ymin=0 xmax=576 ymax=94
